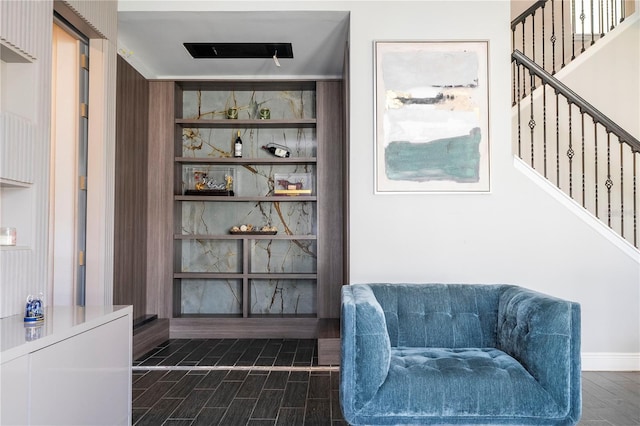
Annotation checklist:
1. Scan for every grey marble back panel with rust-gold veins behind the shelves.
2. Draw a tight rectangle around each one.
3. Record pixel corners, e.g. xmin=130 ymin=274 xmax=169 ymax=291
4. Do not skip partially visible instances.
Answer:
xmin=178 ymin=90 xmax=317 ymax=315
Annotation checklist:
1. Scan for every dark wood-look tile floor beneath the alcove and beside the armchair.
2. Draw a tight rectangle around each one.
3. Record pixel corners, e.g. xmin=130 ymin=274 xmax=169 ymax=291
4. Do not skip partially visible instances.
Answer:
xmin=133 ymin=339 xmax=640 ymax=426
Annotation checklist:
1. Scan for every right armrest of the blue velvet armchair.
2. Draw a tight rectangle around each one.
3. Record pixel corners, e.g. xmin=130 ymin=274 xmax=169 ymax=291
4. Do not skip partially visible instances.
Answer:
xmin=498 ymin=287 xmax=582 ymax=421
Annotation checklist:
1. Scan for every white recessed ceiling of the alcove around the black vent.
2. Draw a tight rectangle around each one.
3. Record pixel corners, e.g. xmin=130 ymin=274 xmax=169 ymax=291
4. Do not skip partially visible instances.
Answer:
xmin=118 ymin=11 xmax=349 ymax=80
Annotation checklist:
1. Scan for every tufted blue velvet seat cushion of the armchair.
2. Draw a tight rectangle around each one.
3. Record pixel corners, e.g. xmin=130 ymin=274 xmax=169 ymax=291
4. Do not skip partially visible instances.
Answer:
xmin=360 ymin=347 xmax=564 ymax=424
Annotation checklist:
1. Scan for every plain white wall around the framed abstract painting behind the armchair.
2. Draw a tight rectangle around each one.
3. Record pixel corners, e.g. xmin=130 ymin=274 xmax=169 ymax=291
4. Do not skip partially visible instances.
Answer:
xmin=121 ymin=0 xmax=640 ymax=369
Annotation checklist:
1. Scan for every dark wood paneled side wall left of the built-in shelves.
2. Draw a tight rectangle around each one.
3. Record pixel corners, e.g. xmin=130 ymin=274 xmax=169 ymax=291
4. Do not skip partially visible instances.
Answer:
xmin=113 ymin=57 xmax=149 ymax=318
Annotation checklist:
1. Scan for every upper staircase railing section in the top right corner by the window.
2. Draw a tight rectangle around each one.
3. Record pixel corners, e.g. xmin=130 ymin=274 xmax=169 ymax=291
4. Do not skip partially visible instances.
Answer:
xmin=511 ymin=0 xmax=633 ymax=75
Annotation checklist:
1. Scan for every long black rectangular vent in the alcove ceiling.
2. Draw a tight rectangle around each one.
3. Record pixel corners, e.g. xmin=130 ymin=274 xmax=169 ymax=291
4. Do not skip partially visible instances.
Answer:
xmin=184 ymin=43 xmax=293 ymax=59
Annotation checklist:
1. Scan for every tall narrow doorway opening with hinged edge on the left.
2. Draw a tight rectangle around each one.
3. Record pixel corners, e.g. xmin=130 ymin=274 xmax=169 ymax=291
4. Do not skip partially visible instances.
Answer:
xmin=49 ymin=14 xmax=89 ymax=305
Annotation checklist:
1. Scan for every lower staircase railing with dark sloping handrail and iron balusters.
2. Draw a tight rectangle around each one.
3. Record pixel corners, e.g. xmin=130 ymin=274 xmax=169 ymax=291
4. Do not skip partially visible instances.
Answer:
xmin=511 ymin=50 xmax=640 ymax=248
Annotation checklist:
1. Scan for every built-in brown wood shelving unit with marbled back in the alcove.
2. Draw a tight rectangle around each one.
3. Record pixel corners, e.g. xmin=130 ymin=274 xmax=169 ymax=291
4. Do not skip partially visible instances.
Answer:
xmin=161 ymin=80 xmax=346 ymax=338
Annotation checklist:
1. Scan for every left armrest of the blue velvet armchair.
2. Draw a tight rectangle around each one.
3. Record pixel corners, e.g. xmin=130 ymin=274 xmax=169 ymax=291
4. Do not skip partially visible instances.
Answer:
xmin=340 ymin=284 xmax=391 ymax=418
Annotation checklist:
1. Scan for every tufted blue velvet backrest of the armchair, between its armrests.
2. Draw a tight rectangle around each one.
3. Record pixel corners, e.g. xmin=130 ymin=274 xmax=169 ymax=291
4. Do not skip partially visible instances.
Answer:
xmin=369 ymin=284 xmax=512 ymax=348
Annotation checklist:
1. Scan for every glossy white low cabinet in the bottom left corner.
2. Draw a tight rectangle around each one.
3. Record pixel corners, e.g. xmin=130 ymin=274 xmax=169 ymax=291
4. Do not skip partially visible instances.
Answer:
xmin=0 ymin=306 xmax=132 ymax=425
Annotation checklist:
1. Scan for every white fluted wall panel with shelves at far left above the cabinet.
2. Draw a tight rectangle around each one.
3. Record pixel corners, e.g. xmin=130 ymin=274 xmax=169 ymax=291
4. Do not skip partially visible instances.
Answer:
xmin=0 ymin=1 xmax=53 ymax=317
